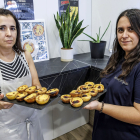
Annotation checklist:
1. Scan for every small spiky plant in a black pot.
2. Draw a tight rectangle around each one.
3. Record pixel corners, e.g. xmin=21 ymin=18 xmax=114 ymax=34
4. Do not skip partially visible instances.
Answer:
xmin=80 ymin=21 xmax=111 ymax=59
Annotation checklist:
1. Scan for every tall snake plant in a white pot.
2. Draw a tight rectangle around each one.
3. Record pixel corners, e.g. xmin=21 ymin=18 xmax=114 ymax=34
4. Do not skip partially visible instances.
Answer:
xmin=54 ymin=6 xmax=86 ymax=61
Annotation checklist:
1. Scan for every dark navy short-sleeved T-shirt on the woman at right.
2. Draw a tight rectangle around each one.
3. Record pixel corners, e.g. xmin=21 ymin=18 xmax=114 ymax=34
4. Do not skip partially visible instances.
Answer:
xmin=92 ymin=59 xmax=140 ymax=140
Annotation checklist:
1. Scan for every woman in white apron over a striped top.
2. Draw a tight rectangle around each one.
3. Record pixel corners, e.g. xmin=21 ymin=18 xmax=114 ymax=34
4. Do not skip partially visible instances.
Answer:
xmin=0 ymin=9 xmax=43 ymax=140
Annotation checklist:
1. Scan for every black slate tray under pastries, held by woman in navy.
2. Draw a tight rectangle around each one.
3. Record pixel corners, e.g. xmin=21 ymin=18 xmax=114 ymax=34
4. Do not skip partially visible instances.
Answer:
xmin=58 ymin=89 xmax=107 ymax=111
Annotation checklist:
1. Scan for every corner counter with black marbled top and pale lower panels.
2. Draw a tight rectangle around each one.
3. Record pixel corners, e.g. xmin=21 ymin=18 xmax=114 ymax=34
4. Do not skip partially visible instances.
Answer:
xmin=35 ymin=53 xmax=109 ymax=140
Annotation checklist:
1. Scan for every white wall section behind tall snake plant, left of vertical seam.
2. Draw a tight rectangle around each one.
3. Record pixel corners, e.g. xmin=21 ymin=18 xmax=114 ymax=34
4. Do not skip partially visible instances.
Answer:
xmin=34 ymin=0 xmax=91 ymax=58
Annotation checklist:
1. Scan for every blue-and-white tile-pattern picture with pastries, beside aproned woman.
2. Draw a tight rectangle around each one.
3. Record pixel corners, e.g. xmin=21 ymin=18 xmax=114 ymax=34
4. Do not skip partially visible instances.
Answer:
xmin=19 ymin=20 xmax=49 ymax=62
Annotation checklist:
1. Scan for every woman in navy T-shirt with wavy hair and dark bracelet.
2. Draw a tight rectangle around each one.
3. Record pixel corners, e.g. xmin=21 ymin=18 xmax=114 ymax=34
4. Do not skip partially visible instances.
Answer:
xmin=84 ymin=9 xmax=140 ymax=140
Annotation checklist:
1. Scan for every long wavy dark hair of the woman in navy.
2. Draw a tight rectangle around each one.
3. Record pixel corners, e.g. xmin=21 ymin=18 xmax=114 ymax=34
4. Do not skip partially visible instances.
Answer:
xmin=100 ymin=9 xmax=140 ymax=79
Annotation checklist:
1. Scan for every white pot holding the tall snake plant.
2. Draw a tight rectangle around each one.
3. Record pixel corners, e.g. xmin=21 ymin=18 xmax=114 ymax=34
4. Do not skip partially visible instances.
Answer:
xmin=61 ymin=48 xmax=73 ymax=62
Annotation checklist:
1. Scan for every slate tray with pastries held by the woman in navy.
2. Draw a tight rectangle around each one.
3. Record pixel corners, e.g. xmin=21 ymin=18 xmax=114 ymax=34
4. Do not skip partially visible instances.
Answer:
xmin=58 ymin=82 xmax=106 ymax=111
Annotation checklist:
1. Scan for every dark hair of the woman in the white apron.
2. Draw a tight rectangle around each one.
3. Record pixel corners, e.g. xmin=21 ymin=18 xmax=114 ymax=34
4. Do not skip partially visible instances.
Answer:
xmin=0 ymin=8 xmax=24 ymax=54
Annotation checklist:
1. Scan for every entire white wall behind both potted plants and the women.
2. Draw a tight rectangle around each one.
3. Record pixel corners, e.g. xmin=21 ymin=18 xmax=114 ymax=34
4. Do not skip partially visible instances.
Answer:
xmin=0 ymin=0 xmax=140 ymax=58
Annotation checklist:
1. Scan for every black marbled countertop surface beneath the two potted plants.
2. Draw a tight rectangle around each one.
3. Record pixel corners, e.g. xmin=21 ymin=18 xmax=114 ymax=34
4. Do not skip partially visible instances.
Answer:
xmin=35 ymin=53 xmax=109 ymax=78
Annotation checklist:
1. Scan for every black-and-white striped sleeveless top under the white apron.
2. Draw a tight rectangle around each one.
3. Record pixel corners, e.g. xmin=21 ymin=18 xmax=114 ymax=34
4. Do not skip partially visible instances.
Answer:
xmin=0 ymin=53 xmax=29 ymax=93
